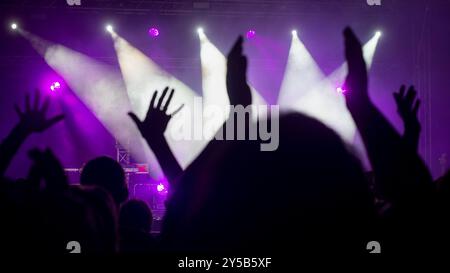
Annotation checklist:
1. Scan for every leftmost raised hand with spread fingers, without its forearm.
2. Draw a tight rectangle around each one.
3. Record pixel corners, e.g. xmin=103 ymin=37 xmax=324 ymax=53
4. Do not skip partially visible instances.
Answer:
xmin=14 ymin=91 xmax=64 ymax=134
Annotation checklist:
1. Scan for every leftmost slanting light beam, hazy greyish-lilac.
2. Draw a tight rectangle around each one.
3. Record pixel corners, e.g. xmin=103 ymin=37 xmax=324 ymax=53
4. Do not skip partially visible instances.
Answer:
xmin=23 ymin=32 xmax=150 ymax=172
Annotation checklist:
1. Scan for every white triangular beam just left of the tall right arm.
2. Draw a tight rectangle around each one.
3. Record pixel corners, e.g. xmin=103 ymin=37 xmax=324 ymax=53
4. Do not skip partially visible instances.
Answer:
xmin=278 ymin=30 xmax=355 ymax=143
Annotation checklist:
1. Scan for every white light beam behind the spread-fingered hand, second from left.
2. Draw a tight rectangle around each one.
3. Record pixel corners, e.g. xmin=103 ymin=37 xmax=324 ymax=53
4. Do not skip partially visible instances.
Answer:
xmin=113 ymin=31 xmax=206 ymax=172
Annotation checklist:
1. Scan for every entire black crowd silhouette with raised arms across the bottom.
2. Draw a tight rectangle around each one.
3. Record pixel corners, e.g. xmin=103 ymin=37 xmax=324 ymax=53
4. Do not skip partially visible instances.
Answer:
xmin=0 ymin=28 xmax=450 ymax=254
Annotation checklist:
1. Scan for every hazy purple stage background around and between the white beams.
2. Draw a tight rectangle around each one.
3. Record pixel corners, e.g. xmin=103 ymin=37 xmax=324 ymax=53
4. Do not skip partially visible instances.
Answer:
xmin=0 ymin=0 xmax=450 ymax=177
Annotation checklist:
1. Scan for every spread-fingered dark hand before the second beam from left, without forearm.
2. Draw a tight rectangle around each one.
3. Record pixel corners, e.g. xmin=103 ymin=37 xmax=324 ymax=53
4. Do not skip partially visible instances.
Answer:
xmin=128 ymin=87 xmax=184 ymax=144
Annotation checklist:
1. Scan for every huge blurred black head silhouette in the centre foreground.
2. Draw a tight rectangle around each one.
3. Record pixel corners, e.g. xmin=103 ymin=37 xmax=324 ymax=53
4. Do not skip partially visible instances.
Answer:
xmin=165 ymin=111 xmax=373 ymax=251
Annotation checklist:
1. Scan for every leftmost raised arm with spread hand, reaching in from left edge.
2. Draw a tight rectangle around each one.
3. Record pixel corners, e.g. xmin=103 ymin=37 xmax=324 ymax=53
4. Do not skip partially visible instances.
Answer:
xmin=0 ymin=91 xmax=64 ymax=177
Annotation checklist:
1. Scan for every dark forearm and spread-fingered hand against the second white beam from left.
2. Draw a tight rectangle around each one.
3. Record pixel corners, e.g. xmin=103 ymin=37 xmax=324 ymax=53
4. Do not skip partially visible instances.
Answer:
xmin=128 ymin=87 xmax=183 ymax=185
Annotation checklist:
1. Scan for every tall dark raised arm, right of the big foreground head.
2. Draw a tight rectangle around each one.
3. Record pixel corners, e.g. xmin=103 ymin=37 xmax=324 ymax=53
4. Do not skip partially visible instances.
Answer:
xmin=344 ymin=28 xmax=433 ymax=204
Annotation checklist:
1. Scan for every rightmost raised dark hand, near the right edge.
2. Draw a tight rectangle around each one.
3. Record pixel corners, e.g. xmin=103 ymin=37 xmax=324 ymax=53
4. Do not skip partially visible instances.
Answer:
xmin=393 ymin=85 xmax=422 ymax=151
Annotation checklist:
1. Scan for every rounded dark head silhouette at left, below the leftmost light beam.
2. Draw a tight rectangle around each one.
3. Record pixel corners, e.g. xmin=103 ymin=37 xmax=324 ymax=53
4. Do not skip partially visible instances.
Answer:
xmin=80 ymin=156 xmax=128 ymax=205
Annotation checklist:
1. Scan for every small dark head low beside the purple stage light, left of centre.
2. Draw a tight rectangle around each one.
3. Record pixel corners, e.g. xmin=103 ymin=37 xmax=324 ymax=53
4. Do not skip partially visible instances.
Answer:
xmin=119 ymin=200 xmax=153 ymax=233
